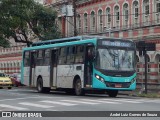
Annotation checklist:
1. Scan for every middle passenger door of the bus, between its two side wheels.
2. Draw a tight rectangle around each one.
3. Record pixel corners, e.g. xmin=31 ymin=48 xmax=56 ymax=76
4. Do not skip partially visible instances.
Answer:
xmin=50 ymin=49 xmax=58 ymax=87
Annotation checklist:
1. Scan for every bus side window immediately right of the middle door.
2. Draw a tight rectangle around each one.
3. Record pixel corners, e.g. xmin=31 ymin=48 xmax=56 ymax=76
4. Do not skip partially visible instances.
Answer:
xmin=58 ymin=47 xmax=67 ymax=64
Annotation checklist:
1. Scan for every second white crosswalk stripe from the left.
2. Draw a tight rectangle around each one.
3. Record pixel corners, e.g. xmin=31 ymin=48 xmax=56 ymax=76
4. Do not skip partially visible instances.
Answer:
xmin=18 ymin=102 xmax=54 ymax=108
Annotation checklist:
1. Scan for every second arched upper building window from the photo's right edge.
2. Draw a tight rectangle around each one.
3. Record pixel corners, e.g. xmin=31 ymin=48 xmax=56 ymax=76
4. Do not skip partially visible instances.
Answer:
xmin=143 ymin=0 xmax=149 ymax=25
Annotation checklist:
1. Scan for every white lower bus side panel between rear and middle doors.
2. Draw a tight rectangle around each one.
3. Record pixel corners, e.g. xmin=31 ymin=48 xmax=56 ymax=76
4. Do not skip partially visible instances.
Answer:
xmin=35 ymin=66 xmax=50 ymax=87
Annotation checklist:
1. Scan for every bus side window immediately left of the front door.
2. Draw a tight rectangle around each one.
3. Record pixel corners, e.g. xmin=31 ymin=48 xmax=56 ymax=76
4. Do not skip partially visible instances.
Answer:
xmin=75 ymin=45 xmax=84 ymax=63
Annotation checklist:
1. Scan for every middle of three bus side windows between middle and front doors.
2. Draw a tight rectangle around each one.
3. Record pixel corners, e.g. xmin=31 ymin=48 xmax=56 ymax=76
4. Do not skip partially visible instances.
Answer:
xmin=67 ymin=46 xmax=75 ymax=64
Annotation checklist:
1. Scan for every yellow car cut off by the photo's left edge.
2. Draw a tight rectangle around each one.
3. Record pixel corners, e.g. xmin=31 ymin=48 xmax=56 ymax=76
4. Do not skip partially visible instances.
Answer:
xmin=0 ymin=72 xmax=12 ymax=89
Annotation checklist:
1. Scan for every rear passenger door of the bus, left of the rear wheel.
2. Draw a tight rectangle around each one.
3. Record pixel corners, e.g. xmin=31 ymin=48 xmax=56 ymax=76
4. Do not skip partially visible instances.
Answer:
xmin=29 ymin=52 xmax=36 ymax=86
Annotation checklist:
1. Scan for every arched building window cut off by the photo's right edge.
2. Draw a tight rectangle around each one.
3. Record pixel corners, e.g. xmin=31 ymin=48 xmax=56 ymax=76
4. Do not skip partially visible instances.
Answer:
xmin=155 ymin=0 xmax=160 ymax=23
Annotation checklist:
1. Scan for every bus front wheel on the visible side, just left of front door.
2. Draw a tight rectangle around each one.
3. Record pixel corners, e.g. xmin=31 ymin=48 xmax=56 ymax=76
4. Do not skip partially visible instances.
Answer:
xmin=74 ymin=79 xmax=84 ymax=96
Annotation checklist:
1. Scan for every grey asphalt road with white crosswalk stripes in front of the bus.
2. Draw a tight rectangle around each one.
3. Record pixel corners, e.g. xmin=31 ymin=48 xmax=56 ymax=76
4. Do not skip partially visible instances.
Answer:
xmin=0 ymin=87 xmax=160 ymax=120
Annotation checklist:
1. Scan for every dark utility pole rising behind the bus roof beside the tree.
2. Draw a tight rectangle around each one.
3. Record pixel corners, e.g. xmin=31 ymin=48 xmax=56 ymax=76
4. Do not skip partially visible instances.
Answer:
xmin=72 ymin=0 xmax=77 ymax=36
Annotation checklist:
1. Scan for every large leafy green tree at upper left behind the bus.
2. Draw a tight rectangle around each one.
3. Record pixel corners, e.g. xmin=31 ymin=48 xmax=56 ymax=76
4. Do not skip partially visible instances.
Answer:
xmin=0 ymin=0 xmax=60 ymax=47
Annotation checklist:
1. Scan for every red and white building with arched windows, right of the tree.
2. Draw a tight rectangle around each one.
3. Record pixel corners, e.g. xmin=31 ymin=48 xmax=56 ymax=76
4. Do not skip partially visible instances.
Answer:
xmin=44 ymin=0 xmax=160 ymax=88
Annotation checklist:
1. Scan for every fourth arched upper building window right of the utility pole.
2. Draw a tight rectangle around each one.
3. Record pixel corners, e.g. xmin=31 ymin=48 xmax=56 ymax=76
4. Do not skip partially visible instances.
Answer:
xmin=98 ymin=10 xmax=103 ymax=32
